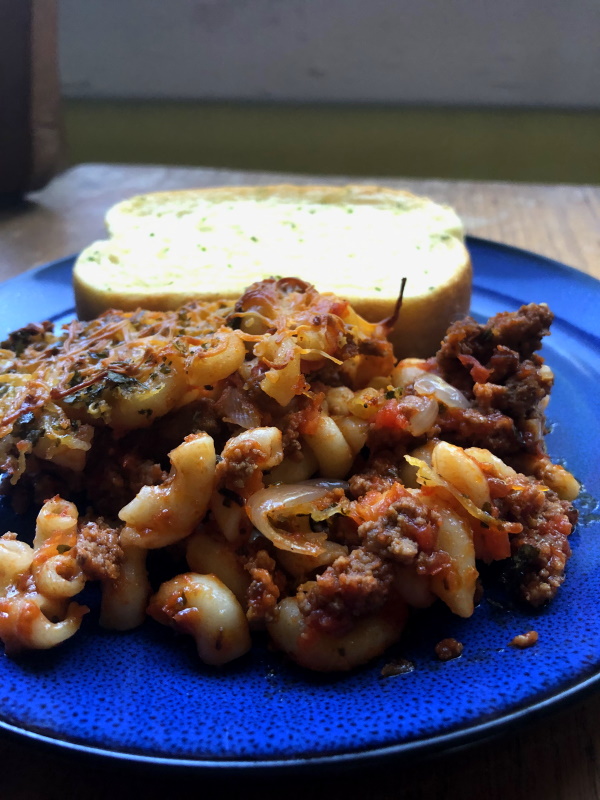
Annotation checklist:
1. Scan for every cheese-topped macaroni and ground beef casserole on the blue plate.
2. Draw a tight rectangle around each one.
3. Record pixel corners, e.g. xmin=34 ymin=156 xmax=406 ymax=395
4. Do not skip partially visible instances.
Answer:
xmin=0 ymin=278 xmax=579 ymax=671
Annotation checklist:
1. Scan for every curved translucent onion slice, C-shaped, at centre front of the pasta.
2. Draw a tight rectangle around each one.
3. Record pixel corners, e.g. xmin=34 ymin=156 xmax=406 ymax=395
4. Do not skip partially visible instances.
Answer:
xmin=246 ymin=479 xmax=348 ymax=556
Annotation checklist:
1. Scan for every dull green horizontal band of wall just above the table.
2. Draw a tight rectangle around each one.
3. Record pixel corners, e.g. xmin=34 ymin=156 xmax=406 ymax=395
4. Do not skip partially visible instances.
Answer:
xmin=64 ymin=100 xmax=600 ymax=183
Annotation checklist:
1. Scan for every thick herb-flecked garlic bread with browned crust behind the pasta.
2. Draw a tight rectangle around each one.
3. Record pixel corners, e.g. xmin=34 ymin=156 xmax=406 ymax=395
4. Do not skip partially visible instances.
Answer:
xmin=74 ymin=185 xmax=471 ymax=357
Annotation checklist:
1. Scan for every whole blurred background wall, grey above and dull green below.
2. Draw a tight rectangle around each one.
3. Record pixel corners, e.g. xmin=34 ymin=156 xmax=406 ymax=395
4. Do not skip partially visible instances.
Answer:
xmin=59 ymin=0 xmax=600 ymax=183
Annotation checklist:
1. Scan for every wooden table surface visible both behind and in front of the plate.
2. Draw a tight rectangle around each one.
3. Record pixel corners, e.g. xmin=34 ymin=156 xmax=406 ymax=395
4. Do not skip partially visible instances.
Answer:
xmin=0 ymin=164 xmax=600 ymax=800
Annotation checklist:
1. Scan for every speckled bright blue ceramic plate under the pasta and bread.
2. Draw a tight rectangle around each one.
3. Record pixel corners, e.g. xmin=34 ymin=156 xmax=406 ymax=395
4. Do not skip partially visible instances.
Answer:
xmin=0 ymin=239 xmax=600 ymax=768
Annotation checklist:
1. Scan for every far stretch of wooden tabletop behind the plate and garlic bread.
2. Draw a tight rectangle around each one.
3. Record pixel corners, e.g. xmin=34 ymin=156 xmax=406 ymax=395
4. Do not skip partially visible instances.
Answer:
xmin=0 ymin=164 xmax=600 ymax=280
